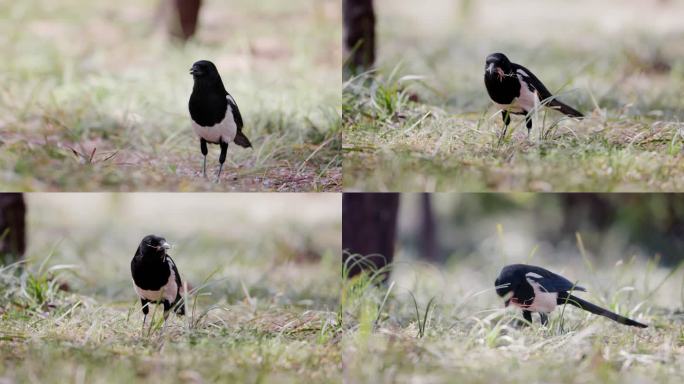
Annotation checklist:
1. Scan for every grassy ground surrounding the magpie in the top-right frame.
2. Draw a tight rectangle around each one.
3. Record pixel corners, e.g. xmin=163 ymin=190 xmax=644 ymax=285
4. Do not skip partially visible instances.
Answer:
xmin=343 ymin=0 xmax=684 ymax=191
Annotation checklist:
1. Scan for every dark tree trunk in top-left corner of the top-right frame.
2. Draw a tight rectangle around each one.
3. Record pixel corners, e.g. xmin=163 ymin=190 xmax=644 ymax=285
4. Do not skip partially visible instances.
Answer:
xmin=342 ymin=0 xmax=375 ymax=75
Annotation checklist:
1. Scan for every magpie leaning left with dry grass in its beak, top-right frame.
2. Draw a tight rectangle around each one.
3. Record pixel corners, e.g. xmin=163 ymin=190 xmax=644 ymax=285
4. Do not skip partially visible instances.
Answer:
xmin=485 ymin=53 xmax=584 ymax=137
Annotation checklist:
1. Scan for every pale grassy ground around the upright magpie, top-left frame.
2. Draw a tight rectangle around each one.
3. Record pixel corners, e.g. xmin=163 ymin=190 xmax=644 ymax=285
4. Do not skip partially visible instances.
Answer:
xmin=0 ymin=0 xmax=341 ymax=191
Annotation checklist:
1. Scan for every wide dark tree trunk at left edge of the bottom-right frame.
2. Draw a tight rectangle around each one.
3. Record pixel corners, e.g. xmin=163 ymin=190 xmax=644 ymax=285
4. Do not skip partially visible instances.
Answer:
xmin=342 ymin=193 xmax=399 ymax=280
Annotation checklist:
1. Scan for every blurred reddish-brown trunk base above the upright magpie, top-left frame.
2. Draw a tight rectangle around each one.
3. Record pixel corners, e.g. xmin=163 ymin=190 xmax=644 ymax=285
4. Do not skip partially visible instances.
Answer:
xmin=158 ymin=0 xmax=202 ymax=41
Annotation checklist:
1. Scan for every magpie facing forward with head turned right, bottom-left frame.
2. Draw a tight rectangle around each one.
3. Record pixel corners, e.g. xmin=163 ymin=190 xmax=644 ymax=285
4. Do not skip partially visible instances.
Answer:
xmin=131 ymin=235 xmax=185 ymax=328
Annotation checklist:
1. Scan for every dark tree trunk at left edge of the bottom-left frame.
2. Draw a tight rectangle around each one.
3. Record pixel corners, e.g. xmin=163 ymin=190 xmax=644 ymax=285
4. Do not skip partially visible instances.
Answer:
xmin=0 ymin=193 xmax=26 ymax=264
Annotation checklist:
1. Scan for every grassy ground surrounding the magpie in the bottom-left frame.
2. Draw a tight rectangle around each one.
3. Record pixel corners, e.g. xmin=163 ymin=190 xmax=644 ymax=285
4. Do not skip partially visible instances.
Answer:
xmin=0 ymin=195 xmax=341 ymax=383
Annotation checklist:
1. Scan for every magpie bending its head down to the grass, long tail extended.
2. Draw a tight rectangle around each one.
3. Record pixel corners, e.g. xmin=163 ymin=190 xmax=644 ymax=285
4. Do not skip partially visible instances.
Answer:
xmin=494 ymin=264 xmax=647 ymax=328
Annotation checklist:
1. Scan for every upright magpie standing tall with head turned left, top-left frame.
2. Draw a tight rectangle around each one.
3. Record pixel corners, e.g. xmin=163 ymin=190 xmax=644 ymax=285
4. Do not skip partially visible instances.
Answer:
xmin=188 ymin=60 xmax=252 ymax=182
